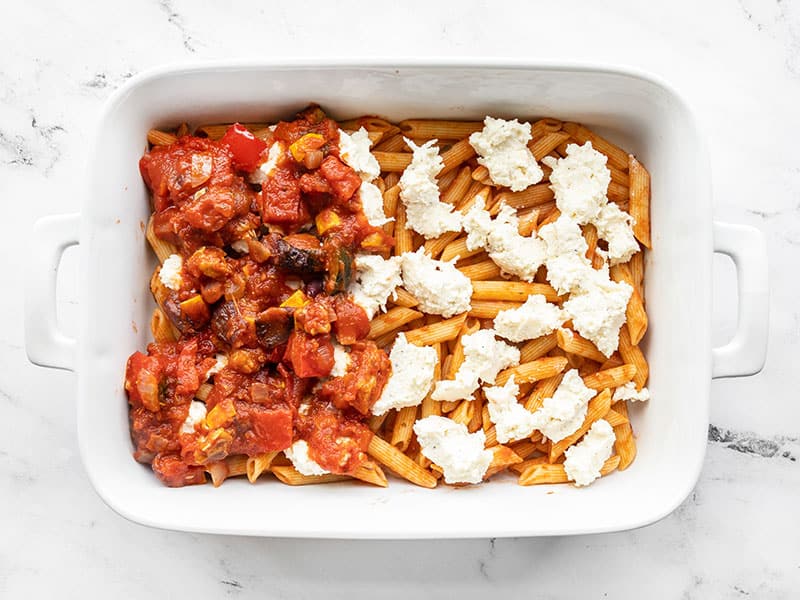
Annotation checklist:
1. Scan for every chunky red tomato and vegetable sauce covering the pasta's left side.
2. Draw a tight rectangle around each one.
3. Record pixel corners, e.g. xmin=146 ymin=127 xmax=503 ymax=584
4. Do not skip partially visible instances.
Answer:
xmin=125 ymin=107 xmax=393 ymax=486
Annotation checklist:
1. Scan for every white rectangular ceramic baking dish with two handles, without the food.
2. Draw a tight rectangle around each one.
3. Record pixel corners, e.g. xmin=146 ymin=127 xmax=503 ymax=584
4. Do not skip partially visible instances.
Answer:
xmin=26 ymin=62 xmax=768 ymax=538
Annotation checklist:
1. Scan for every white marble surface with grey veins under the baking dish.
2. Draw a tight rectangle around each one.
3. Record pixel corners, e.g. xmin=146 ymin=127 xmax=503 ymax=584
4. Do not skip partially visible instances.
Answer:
xmin=0 ymin=0 xmax=800 ymax=599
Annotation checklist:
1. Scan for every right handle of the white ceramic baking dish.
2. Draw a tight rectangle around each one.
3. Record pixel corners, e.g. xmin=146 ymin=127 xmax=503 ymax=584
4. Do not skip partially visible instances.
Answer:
xmin=711 ymin=221 xmax=769 ymax=378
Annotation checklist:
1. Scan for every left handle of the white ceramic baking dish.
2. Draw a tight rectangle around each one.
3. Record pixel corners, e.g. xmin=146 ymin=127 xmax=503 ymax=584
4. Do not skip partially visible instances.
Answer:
xmin=25 ymin=214 xmax=80 ymax=371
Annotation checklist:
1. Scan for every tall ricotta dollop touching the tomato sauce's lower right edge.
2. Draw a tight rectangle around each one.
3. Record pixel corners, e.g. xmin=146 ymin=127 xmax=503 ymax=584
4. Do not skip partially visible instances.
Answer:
xmin=372 ymin=333 xmax=439 ymax=415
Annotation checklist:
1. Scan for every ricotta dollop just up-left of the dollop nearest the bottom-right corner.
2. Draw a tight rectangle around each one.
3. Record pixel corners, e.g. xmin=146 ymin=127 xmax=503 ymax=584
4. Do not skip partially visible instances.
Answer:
xmin=533 ymin=369 xmax=597 ymax=442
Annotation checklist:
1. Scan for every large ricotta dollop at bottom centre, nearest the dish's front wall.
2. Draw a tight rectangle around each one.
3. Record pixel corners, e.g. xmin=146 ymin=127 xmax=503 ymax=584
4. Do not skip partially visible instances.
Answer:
xmin=414 ymin=416 xmax=493 ymax=483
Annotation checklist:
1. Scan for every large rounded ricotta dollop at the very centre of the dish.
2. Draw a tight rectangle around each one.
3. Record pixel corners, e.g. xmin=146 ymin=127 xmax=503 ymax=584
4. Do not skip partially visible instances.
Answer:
xmin=401 ymin=247 xmax=472 ymax=318
